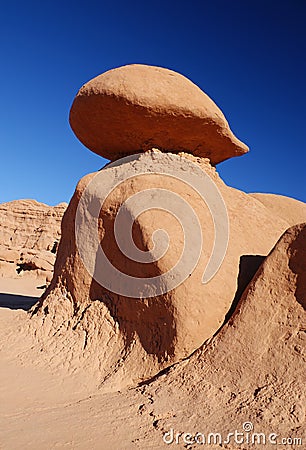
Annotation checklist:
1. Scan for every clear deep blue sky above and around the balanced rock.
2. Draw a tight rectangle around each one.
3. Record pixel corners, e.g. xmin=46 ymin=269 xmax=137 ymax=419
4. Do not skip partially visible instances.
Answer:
xmin=0 ymin=0 xmax=306 ymax=205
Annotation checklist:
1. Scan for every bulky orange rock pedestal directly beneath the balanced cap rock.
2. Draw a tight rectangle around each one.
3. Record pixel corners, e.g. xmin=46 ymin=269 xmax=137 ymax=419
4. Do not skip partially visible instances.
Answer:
xmin=29 ymin=152 xmax=306 ymax=389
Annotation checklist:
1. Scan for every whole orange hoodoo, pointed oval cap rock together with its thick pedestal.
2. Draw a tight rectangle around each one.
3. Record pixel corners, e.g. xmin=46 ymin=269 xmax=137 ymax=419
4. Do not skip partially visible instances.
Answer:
xmin=25 ymin=65 xmax=306 ymax=389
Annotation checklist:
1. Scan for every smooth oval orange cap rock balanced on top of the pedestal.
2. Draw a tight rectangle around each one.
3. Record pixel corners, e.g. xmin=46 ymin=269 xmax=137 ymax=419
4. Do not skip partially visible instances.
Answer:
xmin=70 ymin=64 xmax=248 ymax=164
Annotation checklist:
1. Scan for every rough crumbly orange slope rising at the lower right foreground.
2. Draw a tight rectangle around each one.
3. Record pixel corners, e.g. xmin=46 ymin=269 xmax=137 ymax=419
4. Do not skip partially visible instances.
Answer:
xmin=129 ymin=224 xmax=306 ymax=449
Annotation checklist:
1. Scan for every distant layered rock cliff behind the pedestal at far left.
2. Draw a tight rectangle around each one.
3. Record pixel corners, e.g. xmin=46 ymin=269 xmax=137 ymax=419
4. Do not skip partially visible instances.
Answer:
xmin=0 ymin=200 xmax=67 ymax=282
